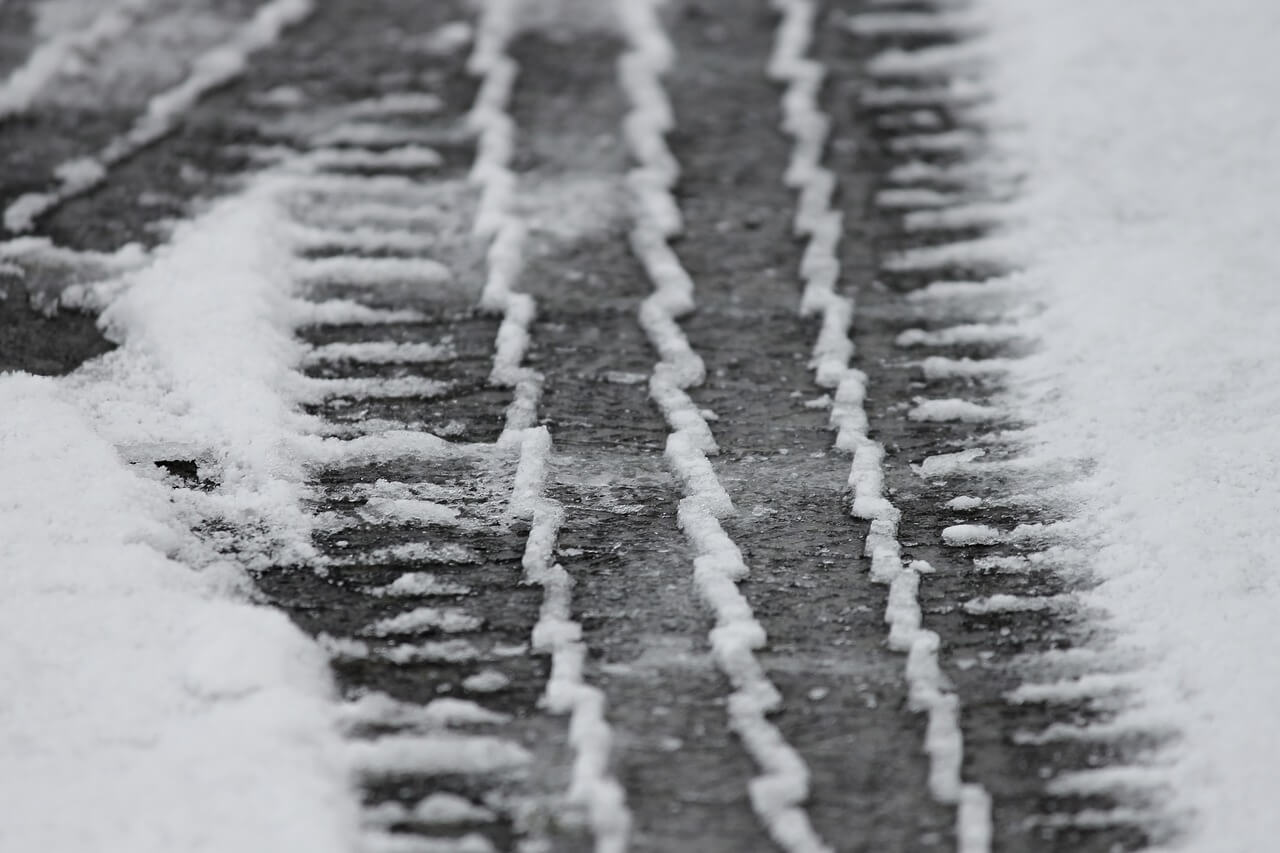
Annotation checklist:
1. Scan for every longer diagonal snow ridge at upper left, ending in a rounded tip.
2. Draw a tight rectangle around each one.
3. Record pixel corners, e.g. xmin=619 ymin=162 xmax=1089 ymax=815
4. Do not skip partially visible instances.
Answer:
xmin=4 ymin=0 xmax=314 ymax=232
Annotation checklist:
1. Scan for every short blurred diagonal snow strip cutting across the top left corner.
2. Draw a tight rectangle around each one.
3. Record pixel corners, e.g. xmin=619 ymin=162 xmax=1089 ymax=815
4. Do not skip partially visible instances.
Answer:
xmin=0 ymin=0 xmax=155 ymax=122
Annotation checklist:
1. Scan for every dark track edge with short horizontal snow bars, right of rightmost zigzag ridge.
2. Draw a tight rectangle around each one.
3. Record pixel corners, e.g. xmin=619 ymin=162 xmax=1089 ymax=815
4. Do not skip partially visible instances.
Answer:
xmin=822 ymin=4 xmax=1167 ymax=850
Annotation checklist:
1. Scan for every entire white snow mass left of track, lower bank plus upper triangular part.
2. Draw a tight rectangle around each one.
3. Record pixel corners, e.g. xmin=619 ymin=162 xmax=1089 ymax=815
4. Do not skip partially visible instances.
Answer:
xmin=0 ymin=178 xmax=357 ymax=853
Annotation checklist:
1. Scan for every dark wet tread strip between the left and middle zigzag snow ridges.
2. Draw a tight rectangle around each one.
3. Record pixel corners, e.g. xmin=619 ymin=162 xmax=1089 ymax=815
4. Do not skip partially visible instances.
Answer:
xmin=513 ymin=19 xmax=771 ymax=853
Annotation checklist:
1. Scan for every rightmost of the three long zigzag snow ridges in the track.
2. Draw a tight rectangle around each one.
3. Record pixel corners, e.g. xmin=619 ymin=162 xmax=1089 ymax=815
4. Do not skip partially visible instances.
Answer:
xmin=768 ymin=0 xmax=992 ymax=853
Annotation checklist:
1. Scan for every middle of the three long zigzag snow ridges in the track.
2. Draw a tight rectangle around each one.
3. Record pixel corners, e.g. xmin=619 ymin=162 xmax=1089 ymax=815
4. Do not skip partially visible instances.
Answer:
xmin=616 ymin=0 xmax=832 ymax=853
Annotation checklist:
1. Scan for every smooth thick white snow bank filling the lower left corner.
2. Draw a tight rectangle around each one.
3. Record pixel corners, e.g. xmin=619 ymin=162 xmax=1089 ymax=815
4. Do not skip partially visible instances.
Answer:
xmin=0 ymin=374 xmax=356 ymax=853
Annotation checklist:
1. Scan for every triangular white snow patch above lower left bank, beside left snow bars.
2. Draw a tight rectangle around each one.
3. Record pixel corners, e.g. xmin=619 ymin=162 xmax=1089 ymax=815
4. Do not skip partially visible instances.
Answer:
xmin=65 ymin=181 xmax=311 ymax=561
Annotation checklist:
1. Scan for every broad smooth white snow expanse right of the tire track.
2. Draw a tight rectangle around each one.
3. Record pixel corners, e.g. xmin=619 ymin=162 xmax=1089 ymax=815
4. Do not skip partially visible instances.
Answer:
xmin=978 ymin=0 xmax=1280 ymax=853
